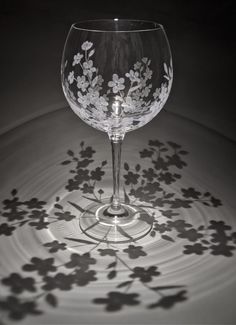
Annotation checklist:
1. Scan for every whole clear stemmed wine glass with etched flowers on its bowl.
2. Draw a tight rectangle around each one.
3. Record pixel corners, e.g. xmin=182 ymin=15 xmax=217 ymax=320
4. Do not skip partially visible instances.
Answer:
xmin=61 ymin=18 xmax=173 ymax=242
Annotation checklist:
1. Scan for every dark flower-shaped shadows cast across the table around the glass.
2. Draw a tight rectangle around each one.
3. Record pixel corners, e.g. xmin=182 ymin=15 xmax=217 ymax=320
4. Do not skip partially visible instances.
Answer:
xmin=0 ymin=140 xmax=236 ymax=320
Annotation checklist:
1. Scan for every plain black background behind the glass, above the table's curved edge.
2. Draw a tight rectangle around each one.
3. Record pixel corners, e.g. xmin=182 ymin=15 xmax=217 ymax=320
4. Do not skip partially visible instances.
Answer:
xmin=0 ymin=0 xmax=236 ymax=140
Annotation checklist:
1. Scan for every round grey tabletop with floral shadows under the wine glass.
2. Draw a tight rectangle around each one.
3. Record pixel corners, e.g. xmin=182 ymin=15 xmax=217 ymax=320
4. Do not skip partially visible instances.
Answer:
xmin=0 ymin=108 xmax=236 ymax=324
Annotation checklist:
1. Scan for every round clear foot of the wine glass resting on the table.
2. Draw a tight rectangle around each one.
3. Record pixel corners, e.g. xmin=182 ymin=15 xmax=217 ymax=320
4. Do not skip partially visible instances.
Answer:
xmin=79 ymin=199 xmax=152 ymax=243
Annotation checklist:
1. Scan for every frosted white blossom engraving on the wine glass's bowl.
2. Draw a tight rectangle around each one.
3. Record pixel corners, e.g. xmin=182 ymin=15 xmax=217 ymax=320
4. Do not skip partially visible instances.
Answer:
xmin=63 ymin=41 xmax=173 ymax=133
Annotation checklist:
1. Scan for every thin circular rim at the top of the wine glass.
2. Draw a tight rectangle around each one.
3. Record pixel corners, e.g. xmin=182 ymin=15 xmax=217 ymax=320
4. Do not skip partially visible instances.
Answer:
xmin=71 ymin=18 xmax=164 ymax=33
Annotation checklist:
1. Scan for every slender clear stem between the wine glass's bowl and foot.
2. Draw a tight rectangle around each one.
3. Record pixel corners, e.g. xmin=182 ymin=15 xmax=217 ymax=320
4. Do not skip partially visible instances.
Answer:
xmin=111 ymin=138 xmax=123 ymax=211
